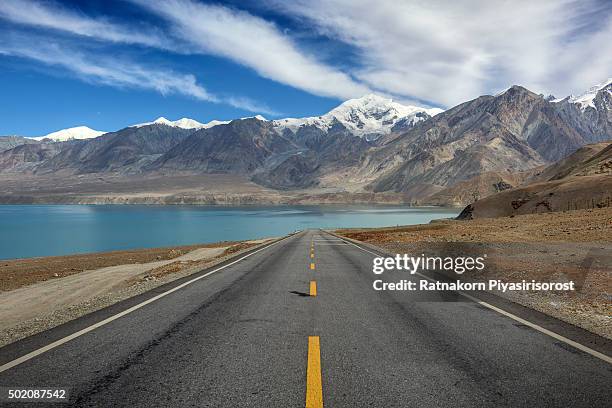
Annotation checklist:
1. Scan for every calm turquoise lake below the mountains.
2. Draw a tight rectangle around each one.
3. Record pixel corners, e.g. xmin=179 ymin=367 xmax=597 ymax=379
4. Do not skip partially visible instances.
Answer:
xmin=0 ymin=205 xmax=458 ymax=259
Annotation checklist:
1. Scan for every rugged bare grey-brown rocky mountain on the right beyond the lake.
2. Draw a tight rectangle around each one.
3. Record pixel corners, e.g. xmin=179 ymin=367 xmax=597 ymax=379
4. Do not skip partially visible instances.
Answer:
xmin=359 ymin=86 xmax=611 ymax=199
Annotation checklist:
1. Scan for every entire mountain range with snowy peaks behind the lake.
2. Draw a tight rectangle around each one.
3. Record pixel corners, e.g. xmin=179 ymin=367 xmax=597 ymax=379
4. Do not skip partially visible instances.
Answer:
xmin=0 ymin=80 xmax=612 ymax=210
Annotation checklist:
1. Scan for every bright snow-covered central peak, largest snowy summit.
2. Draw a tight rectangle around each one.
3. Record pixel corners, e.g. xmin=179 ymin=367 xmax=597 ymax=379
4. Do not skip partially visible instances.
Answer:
xmin=273 ymin=94 xmax=442 ymax=139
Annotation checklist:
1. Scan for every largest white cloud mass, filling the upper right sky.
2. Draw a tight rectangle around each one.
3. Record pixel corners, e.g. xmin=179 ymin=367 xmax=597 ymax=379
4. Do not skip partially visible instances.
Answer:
xmin=269 ymin=0 xmax=612 ymax=106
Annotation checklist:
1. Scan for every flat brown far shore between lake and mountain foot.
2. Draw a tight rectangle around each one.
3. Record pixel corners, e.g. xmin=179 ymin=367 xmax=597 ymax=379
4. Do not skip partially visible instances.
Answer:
xmin=0 ymin=173 xmax=467 ymax=208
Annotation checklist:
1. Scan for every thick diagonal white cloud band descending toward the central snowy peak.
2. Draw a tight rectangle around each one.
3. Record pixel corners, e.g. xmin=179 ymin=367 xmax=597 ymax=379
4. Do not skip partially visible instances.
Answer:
xmin=132 ymin=0 xmax=371 ymax=99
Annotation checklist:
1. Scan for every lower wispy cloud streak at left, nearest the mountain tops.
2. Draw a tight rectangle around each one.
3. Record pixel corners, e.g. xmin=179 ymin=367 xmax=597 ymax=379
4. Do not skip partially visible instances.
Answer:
xmin=0 ymin=35 xmax=275 ymax=114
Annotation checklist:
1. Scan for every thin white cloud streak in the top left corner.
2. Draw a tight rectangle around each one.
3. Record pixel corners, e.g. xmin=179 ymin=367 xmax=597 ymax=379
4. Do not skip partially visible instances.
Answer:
xmin=0 ymin=0 xmax=172 ymax=48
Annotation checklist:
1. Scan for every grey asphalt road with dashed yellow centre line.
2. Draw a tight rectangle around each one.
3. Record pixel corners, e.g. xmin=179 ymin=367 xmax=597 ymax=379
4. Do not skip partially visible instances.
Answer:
xmin=0 ymin=231 xmax=612 ymax=408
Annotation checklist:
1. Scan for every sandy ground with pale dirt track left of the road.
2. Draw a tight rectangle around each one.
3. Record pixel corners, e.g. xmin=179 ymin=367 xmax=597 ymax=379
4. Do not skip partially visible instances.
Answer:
xmin=0 ymin=239 xmax=269 ymax=346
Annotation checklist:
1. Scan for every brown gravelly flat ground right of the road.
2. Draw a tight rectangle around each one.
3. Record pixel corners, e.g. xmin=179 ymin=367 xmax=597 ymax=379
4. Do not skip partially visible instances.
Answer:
xmin=336 ymin=208 xmax=612 ymax=339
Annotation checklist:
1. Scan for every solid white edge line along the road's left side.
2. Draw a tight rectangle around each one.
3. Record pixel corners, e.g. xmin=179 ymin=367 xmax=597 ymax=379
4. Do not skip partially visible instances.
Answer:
xmin=0 ymin=234 xmax=296 ymax=373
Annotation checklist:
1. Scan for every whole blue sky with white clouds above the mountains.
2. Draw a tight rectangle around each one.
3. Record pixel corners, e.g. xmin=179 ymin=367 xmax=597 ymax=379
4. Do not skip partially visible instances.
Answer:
xmin=0 ymin=0 xmax=612 ymax=136
